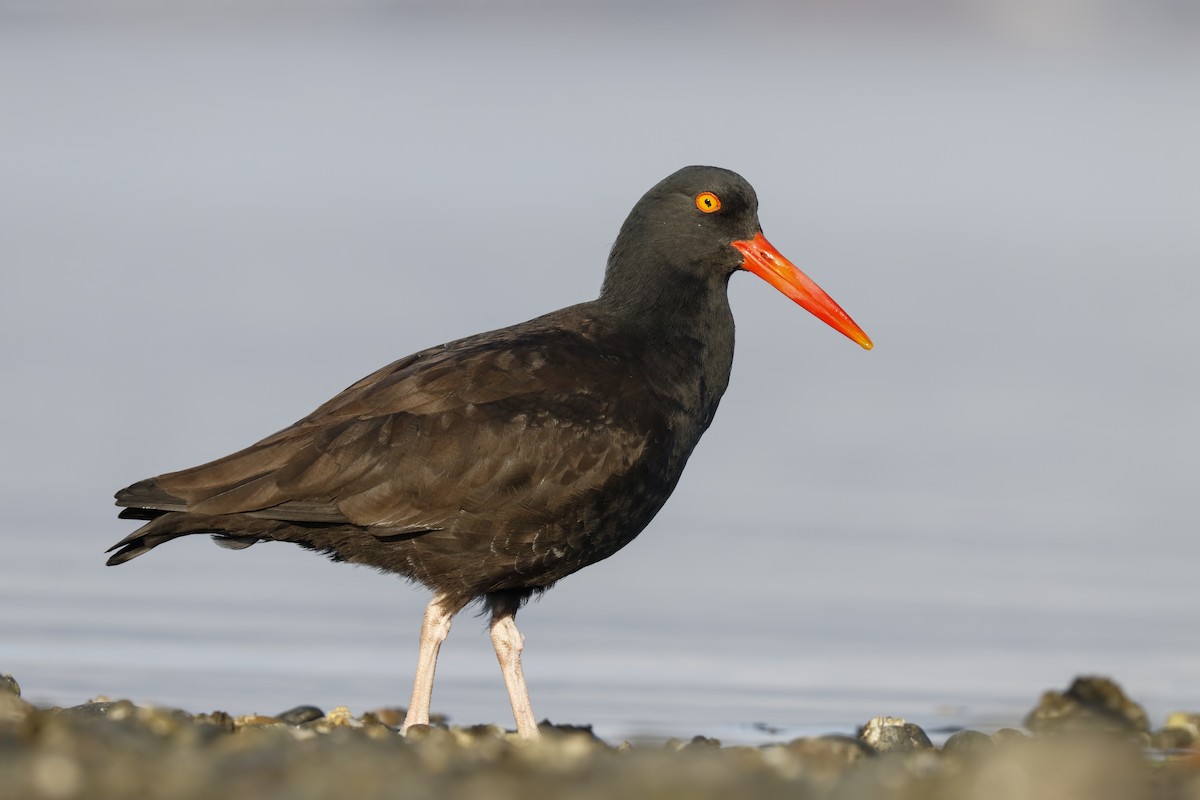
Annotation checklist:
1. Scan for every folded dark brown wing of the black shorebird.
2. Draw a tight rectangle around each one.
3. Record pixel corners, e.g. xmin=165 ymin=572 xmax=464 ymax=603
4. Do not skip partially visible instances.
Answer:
xmin=118 ymin=320 xmax=654 ymax=531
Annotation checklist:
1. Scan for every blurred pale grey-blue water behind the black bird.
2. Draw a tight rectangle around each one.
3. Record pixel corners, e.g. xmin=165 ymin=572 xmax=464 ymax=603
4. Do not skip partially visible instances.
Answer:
xmin=0 ymin=0 xmax=1200 ymax=738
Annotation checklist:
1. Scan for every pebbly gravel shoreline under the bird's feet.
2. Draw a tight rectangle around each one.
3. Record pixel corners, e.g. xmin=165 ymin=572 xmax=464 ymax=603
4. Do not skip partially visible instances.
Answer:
xmin=0 ymin=676 xmax=1200 ymax=800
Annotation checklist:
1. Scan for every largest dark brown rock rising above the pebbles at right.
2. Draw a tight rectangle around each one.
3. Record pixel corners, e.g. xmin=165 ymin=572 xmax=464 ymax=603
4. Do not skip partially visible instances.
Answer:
xmin=1025 ymin=676 xmax=1150 ymax=733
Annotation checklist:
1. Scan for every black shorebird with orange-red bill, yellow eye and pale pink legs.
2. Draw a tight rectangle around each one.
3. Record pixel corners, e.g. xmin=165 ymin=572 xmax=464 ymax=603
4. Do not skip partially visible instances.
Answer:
xmin=108 ymin=166 xmax=874 ymax=739
